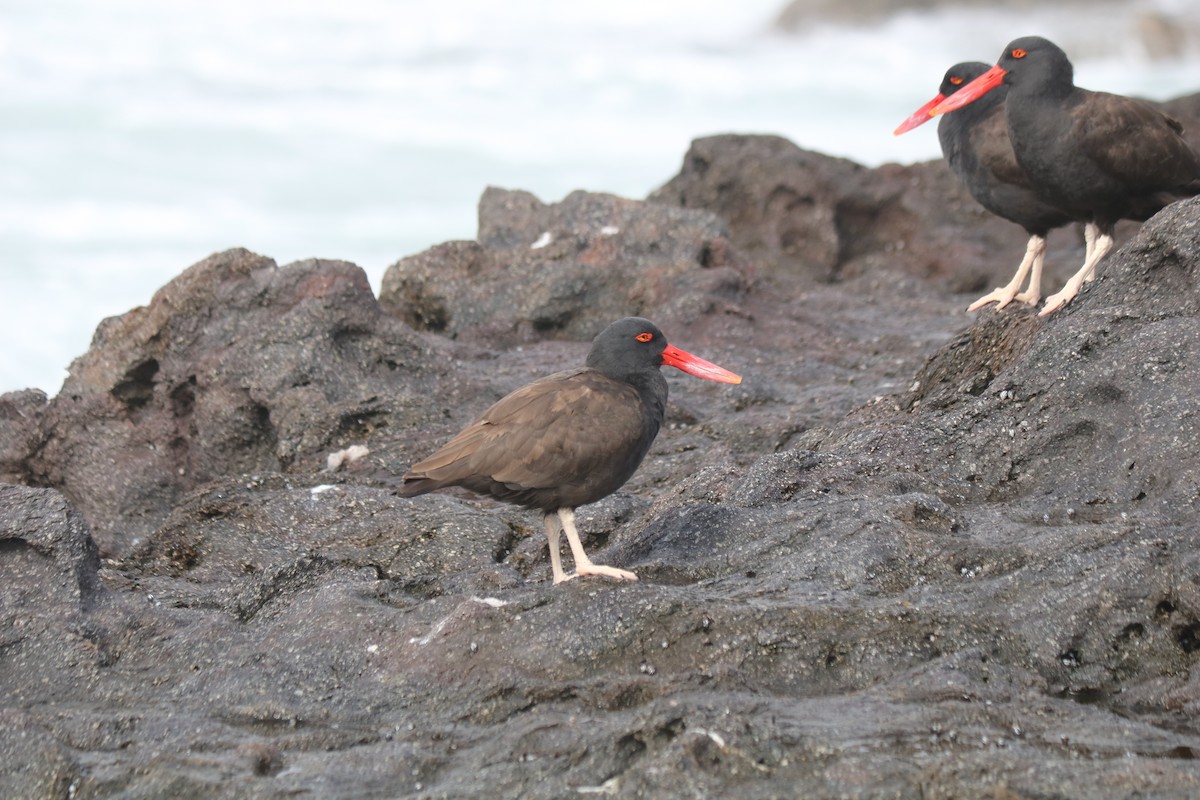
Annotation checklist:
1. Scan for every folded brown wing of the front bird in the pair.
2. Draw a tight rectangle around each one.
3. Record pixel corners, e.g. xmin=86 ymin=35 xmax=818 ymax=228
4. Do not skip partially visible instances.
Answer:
xmin=1072 ymin=92 xmax=1200 ymax=192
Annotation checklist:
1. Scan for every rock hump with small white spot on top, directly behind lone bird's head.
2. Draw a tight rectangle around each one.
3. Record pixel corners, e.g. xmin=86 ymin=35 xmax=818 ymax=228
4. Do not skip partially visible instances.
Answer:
xmin=379 ymin=188 xmax=748 ymax=344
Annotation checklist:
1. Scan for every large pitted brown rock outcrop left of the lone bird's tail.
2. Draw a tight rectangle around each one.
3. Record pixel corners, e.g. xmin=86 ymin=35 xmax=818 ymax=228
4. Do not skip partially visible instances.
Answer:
xmin=28 ymin=251 xmax=451 ymax=554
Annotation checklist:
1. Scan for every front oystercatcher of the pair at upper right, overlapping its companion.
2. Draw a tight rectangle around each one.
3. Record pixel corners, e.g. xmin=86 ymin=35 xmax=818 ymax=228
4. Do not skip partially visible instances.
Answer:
xmin=930 ymin=36 xmax=1200 ymax=317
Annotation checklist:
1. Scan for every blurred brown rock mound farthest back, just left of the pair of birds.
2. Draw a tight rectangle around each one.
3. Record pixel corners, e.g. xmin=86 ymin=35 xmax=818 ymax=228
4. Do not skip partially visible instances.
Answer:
xmin=650 ymin=134 xmax=1084 ymax=291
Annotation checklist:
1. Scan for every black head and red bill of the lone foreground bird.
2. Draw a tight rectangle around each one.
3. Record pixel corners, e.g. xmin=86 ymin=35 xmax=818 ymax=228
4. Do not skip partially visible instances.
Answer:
xmin=587 ymin=317 xmax=742 ymax=384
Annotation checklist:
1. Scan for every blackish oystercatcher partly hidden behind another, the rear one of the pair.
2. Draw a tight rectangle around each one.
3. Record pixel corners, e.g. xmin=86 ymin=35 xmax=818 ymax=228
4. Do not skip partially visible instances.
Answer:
xmin=895 ymin=61 xmax=1072 ymax=311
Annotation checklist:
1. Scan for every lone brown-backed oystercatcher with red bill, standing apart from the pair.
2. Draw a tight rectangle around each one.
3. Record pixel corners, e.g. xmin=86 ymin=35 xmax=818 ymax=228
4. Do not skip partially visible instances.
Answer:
xmin=400 ymin=317 xmax=742 ymax=583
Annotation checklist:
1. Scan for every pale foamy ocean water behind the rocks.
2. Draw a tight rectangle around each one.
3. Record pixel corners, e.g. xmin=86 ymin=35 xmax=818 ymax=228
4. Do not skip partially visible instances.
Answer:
xmin=0 ymin=0 xmax=1200 ymax=395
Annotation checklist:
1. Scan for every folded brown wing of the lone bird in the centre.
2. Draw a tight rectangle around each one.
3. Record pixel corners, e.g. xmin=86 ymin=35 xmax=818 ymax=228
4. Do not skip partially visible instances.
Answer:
xmin=404 ymin=369 xmax=642 ymax=489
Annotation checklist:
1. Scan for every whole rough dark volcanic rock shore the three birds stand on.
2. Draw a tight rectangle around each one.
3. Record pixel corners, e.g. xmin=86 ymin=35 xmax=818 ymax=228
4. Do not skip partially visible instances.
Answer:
xmin=0 ymin=122 xmax=1200 ymax=799
